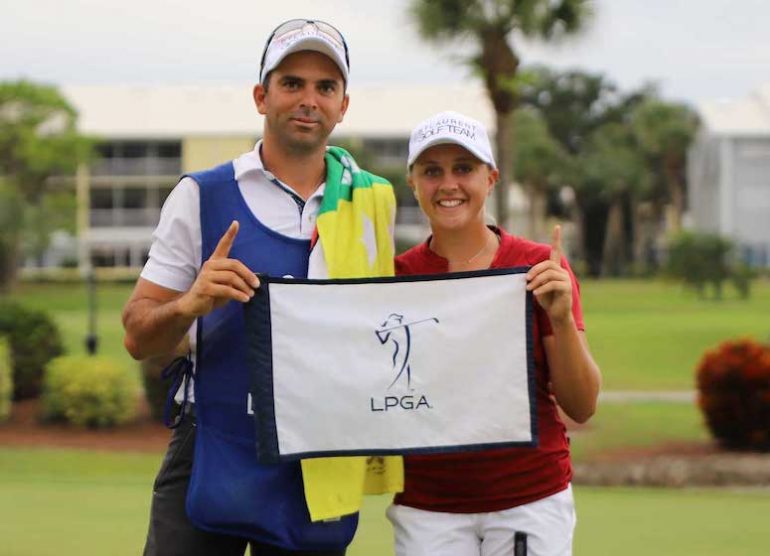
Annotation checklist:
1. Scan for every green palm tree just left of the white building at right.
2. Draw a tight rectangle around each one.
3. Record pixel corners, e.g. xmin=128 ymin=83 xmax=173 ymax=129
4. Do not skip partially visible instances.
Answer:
xmin=631 ymin=98 xmax=698 ymax=232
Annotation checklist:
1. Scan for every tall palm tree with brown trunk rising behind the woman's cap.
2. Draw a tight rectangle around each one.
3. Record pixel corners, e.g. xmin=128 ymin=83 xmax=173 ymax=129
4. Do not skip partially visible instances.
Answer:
xmin=409 ymin=0 xmax=592 ymax=225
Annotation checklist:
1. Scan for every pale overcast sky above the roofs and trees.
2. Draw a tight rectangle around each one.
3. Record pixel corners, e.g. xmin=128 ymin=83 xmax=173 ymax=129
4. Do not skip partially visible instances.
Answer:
xmin=0 ymin=0 xmax=770 ymax=102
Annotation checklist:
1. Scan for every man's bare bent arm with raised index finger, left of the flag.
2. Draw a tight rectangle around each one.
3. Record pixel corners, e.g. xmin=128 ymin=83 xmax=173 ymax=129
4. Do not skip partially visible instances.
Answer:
xmin=123 ymin=221 xmax=259 ymax=359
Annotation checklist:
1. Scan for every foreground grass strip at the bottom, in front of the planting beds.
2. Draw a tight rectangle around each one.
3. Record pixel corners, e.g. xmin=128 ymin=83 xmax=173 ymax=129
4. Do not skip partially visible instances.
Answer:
xmin=0 ymin=447 xmax=770 ymax=556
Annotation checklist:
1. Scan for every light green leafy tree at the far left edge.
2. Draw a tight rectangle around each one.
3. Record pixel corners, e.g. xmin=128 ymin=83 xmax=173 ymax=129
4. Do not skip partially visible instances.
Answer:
xmin=0 ymin=80 xmax=90 ymax=291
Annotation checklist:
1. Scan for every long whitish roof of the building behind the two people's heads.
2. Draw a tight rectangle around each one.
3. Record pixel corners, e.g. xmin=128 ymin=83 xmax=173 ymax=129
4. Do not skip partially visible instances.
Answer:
xmin=62 ymin=83 xmax=494 ymax=139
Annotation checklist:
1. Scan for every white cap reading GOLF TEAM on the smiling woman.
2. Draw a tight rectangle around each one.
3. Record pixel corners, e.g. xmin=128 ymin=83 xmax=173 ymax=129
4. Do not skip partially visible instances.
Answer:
xmin=407 ymin=111 xmax=497 ymax=168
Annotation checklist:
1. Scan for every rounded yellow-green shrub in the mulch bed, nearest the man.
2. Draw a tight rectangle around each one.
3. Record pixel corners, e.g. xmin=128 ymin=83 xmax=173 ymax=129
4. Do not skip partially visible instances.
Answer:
xmin=42 ymin=355 xmax=139 ymax=427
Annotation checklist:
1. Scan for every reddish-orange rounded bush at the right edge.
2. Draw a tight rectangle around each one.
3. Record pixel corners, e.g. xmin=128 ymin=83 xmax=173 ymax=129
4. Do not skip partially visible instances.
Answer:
xmin=697 ymin=339 xmax=770 ymax=451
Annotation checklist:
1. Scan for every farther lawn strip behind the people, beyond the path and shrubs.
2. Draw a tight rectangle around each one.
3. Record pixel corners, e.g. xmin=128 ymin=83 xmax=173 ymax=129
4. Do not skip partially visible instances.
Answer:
xmin=7 ymin=280 xmax=770 ymax=390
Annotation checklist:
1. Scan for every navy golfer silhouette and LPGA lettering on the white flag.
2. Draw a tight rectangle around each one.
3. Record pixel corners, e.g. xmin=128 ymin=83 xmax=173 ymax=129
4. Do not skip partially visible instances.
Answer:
xmin=370 ymin=313 xmax=439 ymax=411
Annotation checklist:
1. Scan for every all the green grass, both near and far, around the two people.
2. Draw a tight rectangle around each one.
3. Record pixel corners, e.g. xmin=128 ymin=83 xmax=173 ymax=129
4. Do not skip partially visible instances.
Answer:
xmin=0 ymin=281 xmax=770 ymax=556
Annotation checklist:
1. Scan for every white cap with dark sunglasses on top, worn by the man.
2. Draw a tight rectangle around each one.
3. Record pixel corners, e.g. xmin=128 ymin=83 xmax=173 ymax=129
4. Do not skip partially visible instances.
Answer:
xmin=259 ymin=19 xmax=350 ymax=83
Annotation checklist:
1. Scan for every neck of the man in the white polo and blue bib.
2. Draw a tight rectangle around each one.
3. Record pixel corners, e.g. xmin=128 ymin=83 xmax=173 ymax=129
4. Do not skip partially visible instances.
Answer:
xmin=260 ymin=138 xmax=326 ymax=200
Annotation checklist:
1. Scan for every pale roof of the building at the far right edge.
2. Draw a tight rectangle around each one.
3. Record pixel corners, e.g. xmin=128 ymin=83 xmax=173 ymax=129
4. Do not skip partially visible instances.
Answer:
xmin=698 ymin=83 xmax=770 ymax=136
